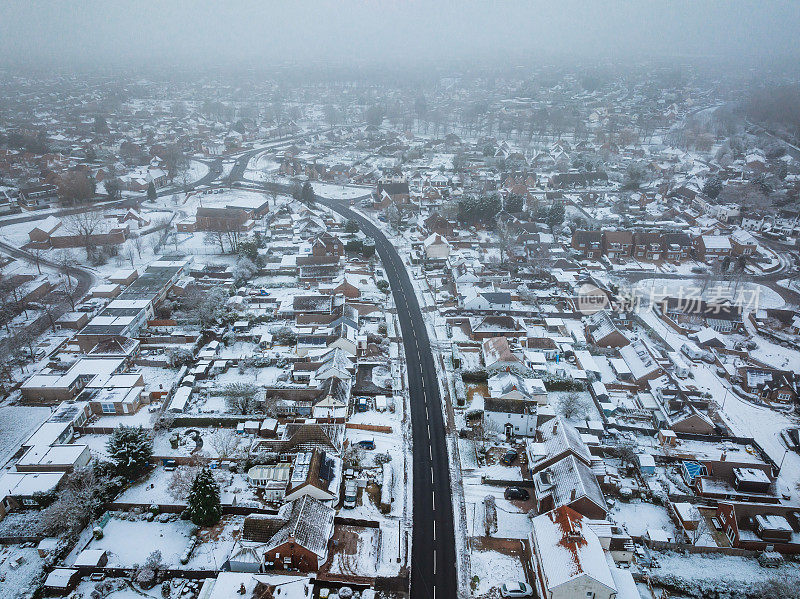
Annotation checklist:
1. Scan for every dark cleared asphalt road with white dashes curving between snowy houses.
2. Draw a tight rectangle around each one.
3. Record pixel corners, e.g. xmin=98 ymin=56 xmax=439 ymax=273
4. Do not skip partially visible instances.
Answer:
xmin=317 ymin=196 xmax=458 ymax=599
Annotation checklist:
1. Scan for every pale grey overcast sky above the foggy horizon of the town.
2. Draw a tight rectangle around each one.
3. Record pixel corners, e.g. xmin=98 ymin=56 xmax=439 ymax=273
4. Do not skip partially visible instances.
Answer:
xmin=0 ymin=0 xmax=800 ymax=68
